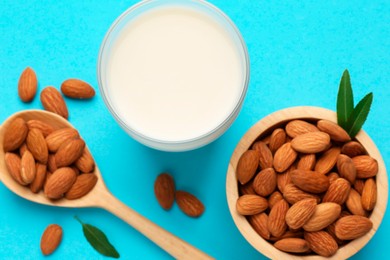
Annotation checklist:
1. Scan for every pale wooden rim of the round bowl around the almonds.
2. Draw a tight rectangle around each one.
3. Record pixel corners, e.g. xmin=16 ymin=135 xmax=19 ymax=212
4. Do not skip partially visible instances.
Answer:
xmin=226 ymin=107 xmax=388 ymax=259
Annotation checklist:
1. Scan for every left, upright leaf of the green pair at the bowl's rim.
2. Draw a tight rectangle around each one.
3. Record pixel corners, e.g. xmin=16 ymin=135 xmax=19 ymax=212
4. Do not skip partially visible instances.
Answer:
xmin=337 ymin=70 xmax=353 ymax=131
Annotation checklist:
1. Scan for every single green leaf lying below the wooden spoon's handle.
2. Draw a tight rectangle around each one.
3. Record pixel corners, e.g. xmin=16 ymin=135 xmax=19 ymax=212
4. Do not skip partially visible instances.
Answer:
xmin=74 ymin=216 xmax=120 ymax=258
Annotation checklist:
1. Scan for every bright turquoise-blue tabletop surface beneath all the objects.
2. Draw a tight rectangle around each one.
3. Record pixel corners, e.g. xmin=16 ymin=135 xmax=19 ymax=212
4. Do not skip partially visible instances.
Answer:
xmin=0 ymin=0 xmax=390 ymax=259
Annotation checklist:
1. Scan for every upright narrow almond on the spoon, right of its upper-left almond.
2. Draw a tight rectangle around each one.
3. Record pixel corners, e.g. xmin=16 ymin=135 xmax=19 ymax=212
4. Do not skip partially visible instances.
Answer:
xmin=26 ymin=128 xmax=49 ymax=164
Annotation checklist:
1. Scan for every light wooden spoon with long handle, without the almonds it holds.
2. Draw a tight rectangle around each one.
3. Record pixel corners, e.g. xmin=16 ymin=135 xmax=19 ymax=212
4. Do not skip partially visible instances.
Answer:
xmin=0 ymin=110 xmax=212 ymax=259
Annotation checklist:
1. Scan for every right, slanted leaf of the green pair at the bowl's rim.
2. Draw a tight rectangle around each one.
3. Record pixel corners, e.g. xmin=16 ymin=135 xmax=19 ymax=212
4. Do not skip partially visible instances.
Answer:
xmin=347 ymin=92 xmax=374 ymax=138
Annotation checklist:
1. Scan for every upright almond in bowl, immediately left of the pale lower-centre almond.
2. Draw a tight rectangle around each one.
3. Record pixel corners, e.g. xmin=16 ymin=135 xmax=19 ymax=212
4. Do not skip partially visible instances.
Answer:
xmin=268 ymin=200 xmax=289 ymax=237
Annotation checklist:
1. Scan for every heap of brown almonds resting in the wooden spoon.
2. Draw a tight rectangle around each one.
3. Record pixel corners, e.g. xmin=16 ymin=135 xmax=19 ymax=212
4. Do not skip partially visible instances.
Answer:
xmin=3 ymin=117 xmax=98 ymax=200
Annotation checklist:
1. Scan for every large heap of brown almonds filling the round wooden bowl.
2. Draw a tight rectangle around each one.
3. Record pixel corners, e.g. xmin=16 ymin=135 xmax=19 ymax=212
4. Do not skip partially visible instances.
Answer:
xmin=236 ymin=120 xmax=378 ymax=257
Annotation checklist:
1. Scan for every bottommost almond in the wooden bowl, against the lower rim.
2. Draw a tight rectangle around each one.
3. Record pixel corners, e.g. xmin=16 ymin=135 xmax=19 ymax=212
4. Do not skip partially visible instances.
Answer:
xmin=304 ymin=231 xmax=339 ymax=257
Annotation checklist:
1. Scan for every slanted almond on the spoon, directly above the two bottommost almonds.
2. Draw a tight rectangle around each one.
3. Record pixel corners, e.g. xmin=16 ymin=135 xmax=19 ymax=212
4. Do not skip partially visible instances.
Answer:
xmin=55 ymin=138 xmax=85 ymax=168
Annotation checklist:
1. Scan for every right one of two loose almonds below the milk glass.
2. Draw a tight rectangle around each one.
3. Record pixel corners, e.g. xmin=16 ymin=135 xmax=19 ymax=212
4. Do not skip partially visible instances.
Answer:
xmin=175 ymin=190 xmax=205 ymax=217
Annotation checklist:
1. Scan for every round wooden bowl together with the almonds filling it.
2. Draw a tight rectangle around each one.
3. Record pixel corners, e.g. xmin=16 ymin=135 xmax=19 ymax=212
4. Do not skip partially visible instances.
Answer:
xmin=226 ymin=107 xmax=388 ymax=259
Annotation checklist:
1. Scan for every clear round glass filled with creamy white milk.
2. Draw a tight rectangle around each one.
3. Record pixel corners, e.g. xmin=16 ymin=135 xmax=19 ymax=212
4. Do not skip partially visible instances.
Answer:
xmin=97 ymin=0 xmax=249 ymax=151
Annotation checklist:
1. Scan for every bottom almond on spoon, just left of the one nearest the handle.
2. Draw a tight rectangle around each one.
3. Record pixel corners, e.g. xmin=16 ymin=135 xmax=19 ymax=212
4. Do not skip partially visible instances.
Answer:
xmin=44 ymin=167 xmax=77 ymax=199
